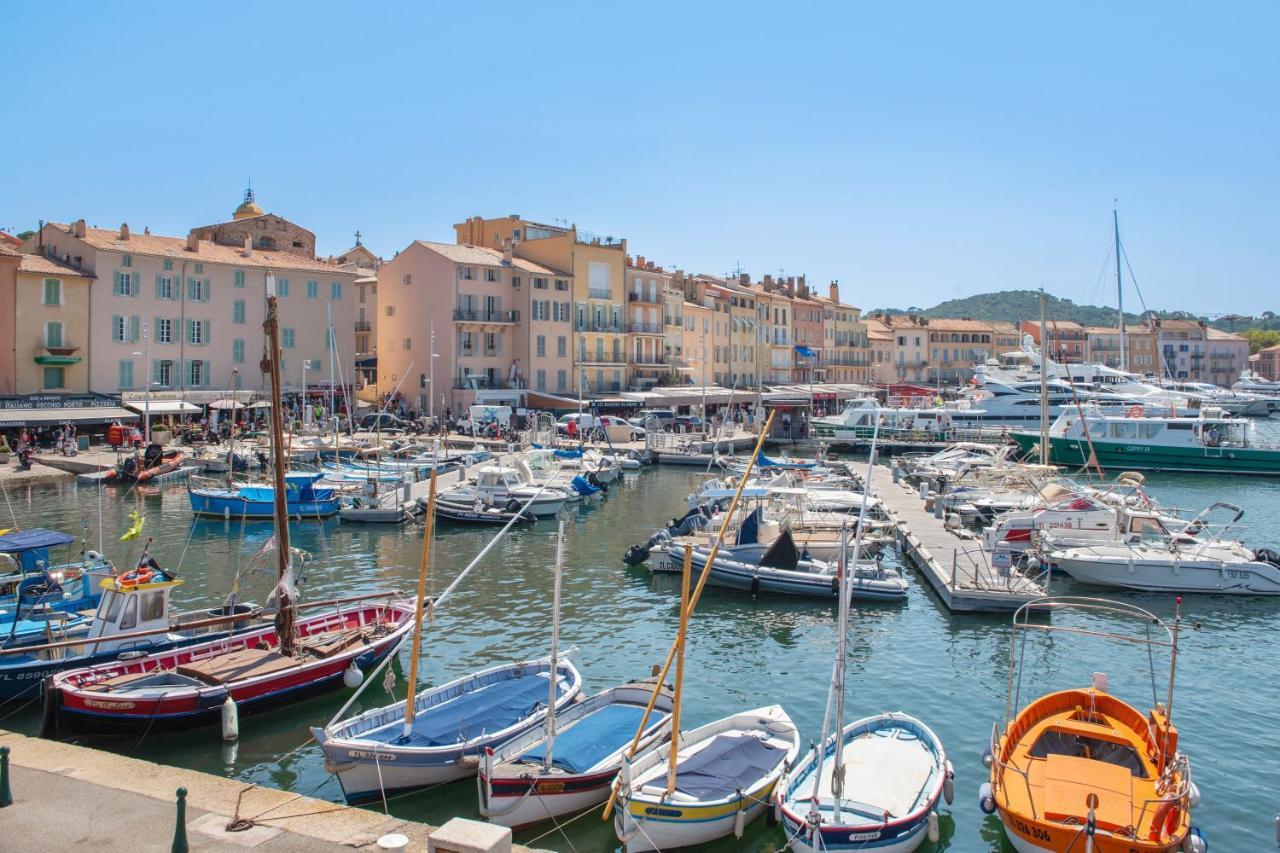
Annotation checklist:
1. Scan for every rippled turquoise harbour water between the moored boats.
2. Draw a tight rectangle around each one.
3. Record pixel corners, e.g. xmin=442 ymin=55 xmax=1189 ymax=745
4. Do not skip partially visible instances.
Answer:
xmin=0 ymin=469 xmax=1280 ymax=852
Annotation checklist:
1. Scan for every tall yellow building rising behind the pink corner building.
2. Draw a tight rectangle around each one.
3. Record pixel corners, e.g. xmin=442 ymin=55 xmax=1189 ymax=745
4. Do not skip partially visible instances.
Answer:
xmin=453 ymin=215 xmax=634 ymax=396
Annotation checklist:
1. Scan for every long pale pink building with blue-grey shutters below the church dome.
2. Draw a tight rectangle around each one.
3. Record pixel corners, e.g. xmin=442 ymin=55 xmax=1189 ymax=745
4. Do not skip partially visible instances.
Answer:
xmin=35 ymin=206 xmax=356 ymax=400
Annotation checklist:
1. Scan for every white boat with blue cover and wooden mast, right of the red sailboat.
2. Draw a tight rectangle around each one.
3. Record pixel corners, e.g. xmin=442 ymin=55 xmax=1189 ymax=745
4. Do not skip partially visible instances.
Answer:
xmin=311 ymin=489 xmax=582 ymax=803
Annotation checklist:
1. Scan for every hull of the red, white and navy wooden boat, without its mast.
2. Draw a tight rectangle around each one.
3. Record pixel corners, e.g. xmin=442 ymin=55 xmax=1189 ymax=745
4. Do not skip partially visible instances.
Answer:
xmin=45 ymin=602 xmax=413 ymax=734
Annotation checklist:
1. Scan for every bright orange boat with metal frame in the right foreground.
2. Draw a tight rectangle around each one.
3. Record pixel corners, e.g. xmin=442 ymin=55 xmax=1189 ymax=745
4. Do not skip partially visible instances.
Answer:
xmin=979 ymin=597 xmax=1206 ymax=853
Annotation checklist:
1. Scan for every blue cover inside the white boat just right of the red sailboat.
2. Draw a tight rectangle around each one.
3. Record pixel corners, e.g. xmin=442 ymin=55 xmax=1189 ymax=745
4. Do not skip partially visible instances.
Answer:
xmin=369 ymin=675 xmax=547 ymax=747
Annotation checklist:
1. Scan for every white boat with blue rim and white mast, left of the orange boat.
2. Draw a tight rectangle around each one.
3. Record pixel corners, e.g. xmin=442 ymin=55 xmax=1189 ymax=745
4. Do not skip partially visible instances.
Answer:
xmin=776 ymin=428 xmax=952 ymax=853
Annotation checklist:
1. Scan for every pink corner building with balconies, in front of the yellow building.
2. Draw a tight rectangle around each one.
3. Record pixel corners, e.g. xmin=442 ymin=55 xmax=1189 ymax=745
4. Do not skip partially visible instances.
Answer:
xmin=378 ymin=241 xmax=573 ymax=414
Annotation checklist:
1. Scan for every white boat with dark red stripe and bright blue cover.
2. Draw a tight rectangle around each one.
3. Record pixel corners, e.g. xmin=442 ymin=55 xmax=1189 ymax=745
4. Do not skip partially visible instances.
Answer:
xmin=479 ymin=683 xmax=672 ymax=827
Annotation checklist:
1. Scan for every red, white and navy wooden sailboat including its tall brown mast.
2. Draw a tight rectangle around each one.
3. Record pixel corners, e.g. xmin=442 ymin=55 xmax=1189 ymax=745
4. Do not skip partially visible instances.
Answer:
xmin=45 ymin=275 xmax=413 ymax=733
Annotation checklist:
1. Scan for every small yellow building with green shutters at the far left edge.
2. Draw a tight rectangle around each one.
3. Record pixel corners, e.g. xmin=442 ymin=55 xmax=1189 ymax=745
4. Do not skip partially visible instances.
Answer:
xmin=0 ymin=245 xmax=93 ymax=394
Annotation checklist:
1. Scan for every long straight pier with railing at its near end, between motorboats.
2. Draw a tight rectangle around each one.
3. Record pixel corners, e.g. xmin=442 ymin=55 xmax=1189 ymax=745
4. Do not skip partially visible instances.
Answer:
xmin=869 ymin=465 xmax=1044 ymax=613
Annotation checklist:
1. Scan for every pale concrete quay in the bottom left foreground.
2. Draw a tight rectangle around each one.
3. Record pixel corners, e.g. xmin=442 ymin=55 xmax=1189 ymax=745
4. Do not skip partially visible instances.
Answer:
xmin=0 ymin=730 xmax=545 ymax=853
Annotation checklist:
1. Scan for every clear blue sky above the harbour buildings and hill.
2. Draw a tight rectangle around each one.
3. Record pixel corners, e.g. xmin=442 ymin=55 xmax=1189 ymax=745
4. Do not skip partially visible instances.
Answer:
xmin=0 ymin=1 xmax=1280 ymax=313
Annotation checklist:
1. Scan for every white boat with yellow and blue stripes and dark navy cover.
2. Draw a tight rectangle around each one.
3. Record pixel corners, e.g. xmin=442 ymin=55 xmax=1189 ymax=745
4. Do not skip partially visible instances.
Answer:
xmin=613 ymin=704 xmax=800 ymax=853
